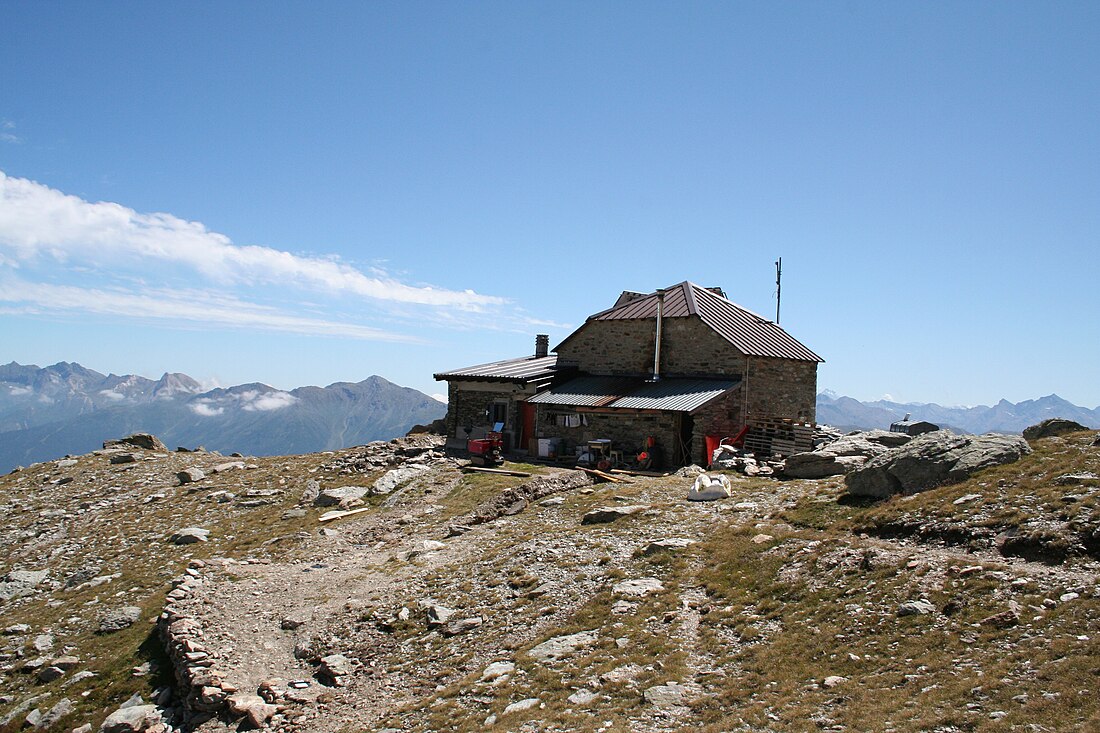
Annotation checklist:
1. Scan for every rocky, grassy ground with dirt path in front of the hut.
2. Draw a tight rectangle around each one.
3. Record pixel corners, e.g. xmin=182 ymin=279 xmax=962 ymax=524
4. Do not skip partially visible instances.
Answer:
xmin=0 ymin=433 xmax=1100 ymax=733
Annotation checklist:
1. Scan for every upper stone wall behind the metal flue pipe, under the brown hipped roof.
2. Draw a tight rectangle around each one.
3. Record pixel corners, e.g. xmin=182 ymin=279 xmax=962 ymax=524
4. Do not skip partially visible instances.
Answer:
xmin=557 ymin=317 xmax=745 ymax=376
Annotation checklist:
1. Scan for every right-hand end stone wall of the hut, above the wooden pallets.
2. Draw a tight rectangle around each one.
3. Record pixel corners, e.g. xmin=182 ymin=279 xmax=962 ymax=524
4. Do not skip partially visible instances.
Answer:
xmin=741 ymin=357 xmax=817 ymax=424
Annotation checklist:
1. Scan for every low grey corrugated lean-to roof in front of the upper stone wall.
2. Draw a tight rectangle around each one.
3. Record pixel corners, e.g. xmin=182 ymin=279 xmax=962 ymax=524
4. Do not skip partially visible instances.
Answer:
xmin=527 ymin=376 xmax=740 ymax=413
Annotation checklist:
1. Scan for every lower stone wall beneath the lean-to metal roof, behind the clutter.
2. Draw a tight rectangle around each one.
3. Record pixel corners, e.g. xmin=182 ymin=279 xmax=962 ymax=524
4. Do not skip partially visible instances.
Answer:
xmin=536 ymin=405 xmax=682 ymax=466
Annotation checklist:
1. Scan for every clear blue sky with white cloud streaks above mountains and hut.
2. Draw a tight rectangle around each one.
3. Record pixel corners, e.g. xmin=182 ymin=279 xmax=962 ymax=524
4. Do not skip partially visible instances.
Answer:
xmin=0 ymin=2 xmax=1100 ymax=407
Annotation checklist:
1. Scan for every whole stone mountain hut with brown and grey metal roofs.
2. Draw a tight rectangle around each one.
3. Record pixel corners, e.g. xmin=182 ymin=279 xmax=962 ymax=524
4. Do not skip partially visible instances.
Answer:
xmin=436 ymin=282 xmax=822 ymax=464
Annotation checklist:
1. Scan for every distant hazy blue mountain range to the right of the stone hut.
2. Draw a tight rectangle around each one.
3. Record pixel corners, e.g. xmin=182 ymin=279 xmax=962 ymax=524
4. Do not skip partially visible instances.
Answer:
xmin=817 ymin=392 xmax=1100 ymax=435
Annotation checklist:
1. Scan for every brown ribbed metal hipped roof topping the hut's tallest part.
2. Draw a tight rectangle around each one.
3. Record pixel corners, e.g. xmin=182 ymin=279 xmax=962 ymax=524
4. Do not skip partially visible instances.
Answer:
xmin=572 ymin=282 xmax=824 ymax=361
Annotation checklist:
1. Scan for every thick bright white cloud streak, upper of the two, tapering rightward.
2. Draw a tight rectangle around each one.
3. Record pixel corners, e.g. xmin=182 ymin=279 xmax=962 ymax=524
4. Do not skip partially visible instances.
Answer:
xmin=0 ymin=172 xmax=506 ymax=311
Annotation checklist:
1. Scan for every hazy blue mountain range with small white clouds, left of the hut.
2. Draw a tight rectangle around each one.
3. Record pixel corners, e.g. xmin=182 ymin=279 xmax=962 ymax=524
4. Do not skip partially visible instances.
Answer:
xmin=0 ymin=362 xmax=447 ymax=471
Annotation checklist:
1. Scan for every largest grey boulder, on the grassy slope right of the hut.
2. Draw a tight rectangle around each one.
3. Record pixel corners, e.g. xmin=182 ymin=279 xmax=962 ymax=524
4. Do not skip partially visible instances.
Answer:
xmin=846 ymin=430 xmax=1031 ymax=499
